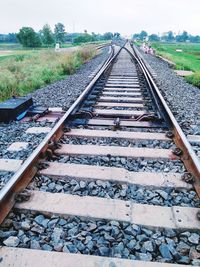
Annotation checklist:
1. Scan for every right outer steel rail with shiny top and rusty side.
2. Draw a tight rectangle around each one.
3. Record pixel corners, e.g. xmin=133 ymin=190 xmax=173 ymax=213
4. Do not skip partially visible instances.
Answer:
xmin=131 ymin=43 xmax=200 ymax=196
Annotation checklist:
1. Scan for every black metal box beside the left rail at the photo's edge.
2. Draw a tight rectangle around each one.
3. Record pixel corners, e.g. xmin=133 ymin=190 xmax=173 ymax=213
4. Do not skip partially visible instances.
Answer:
xmin=0 ymin=97 xmax=33 ymax=122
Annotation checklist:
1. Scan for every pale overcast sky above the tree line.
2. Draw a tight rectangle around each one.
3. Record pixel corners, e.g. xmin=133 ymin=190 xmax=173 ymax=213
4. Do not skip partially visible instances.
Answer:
xmin=0 ymin=0 xmax=200 ymax=35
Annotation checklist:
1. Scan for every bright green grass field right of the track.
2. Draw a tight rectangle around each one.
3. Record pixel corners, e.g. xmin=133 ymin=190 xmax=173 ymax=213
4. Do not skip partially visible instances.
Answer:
xmin=152 ymin=43 xmax=200 ymax=88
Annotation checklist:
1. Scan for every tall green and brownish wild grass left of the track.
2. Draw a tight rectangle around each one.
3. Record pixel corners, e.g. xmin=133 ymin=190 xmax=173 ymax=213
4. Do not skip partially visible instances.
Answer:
xmin=0 ymin=46 xmax=96 ymax=101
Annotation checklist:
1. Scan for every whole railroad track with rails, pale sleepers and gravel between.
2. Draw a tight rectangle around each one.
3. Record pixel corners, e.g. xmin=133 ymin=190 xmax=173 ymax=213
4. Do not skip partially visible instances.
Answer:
xmin=0 ymin=43 xmax=200 ymax=267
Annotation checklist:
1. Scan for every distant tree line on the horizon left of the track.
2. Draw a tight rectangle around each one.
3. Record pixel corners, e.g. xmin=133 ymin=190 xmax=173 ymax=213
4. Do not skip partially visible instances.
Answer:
xmin=0 ymin=23 xmax=120 ymax=47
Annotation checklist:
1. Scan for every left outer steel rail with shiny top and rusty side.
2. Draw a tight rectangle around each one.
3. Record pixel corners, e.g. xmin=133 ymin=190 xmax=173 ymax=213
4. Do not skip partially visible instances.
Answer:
xmin=0 ymin=43 xmax=122 ymax=223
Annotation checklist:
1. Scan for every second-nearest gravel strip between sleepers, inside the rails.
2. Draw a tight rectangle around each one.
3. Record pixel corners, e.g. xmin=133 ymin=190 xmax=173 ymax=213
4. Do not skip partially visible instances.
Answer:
xmin=28 ymin=175 xmax=200 ymax=207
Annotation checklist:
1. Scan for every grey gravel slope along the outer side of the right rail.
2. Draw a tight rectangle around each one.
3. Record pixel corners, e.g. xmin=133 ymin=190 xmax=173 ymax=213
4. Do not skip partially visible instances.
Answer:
xmin=140 ymin=48 xmax=200 ymax=135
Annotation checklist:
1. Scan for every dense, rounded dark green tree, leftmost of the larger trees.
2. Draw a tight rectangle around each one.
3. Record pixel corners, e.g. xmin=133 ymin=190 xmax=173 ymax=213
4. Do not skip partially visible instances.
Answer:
xmin=17 ymin=27 xmax=41 ymax=47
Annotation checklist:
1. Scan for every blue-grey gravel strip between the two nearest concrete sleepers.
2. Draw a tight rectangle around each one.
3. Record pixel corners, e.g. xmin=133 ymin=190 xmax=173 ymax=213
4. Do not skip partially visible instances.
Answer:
xmin=0 ymin=213 xmax=200 ymax=266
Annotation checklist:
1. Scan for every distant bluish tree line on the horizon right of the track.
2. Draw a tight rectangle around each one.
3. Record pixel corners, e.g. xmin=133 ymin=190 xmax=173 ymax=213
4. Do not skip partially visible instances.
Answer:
xmin=133 ymin=31 xmax=200 ymax=43
